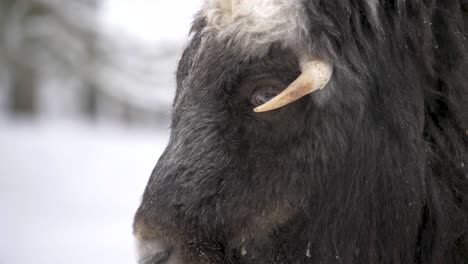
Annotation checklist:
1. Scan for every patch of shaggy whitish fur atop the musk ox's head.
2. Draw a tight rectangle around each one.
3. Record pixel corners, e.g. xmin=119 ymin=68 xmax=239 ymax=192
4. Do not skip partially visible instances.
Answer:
xmin=202 ymin=0 xmax=308 ymax=55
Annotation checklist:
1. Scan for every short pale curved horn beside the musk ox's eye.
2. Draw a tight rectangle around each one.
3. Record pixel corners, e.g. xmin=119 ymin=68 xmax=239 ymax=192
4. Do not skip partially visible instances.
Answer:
xmin=254 ymin=60 xmax=333 ymax=112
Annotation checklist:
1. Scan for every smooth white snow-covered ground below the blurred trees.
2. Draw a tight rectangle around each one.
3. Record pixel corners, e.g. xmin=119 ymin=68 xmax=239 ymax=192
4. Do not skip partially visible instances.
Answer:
xmin=0 ymin=121 xmax=168 ymax=264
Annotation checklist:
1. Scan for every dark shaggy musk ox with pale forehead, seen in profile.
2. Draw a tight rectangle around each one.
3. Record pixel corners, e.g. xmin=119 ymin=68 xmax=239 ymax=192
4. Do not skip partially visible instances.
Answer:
xmin=134 ymin=0 xmax=468 ymax=264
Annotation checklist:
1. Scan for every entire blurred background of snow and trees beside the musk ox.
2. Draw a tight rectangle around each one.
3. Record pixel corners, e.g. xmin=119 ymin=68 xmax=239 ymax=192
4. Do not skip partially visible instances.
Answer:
xmin=0 ymin=0 xmax=202 ymax=264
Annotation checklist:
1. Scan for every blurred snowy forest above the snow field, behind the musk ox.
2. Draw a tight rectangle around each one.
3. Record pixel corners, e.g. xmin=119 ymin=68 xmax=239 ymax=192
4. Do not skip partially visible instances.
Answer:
xmin=0 ymin=0 xmax=196 ymax=126
